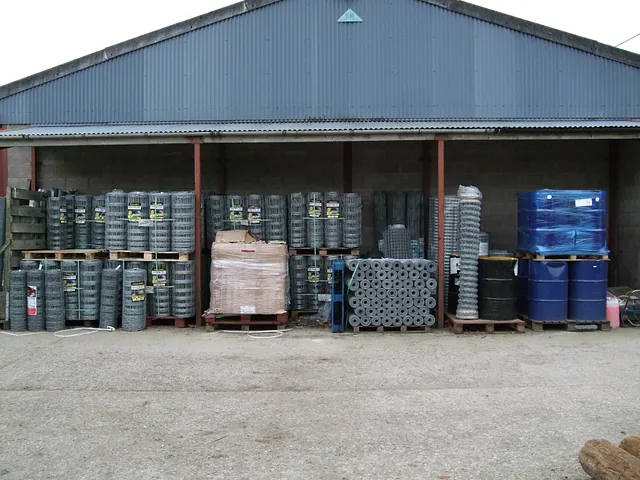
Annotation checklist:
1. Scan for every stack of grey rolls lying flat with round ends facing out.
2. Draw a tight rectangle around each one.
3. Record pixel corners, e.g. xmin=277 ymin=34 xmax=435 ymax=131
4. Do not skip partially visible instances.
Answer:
xmin=346 ymin=259 xmax=438 ymax=327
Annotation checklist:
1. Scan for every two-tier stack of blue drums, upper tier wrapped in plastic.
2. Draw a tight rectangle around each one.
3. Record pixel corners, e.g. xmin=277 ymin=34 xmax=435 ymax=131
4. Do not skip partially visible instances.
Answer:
xmin=516 ymin=190 xmax=608 ymax=323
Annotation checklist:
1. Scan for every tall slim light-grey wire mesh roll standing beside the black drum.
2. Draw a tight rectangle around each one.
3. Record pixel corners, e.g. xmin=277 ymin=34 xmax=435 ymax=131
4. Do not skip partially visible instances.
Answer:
xmin=456 ymin=185 xmax=482 ymax=320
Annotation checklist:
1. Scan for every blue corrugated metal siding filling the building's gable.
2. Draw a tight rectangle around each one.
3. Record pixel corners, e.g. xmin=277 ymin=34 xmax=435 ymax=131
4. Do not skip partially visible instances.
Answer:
xmin=0 ymin=0 xmax=640 ymax=124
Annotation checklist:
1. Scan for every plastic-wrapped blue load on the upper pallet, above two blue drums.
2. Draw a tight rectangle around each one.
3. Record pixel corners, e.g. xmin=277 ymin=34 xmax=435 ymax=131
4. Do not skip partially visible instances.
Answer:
xmin=518 ymin=190 xmax=609 ymax=255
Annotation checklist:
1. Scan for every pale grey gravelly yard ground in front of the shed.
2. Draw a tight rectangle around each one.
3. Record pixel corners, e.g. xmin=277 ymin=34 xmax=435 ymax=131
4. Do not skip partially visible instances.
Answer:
xmin=0 ymin=329 xmax=640 ymax=480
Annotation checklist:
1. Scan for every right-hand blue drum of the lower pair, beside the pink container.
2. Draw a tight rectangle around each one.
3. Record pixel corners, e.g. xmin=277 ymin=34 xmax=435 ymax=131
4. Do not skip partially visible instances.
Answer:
xmin=569 ymin=260 xmax=608 ymax=322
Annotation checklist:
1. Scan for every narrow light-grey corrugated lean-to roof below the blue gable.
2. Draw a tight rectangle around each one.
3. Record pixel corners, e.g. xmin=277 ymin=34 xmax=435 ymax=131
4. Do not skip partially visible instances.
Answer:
xmin=0 ymin=120 xmax=640 ymax=139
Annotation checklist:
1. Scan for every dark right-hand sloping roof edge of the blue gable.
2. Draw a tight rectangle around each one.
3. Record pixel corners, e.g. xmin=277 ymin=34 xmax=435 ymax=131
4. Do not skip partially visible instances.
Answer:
xmin=421 ymin=0 xmax=640 ymax=68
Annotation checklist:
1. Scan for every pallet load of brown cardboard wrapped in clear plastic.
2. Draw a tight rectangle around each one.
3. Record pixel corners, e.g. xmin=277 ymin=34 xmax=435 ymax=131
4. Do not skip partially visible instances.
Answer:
xmin=209 ymin=230 xmax=288 ymax=315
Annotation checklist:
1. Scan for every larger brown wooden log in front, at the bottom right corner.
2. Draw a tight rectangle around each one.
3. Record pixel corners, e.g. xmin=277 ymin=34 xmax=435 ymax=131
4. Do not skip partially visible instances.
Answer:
xmin=578 ymin=440 xmax=640 ymax=480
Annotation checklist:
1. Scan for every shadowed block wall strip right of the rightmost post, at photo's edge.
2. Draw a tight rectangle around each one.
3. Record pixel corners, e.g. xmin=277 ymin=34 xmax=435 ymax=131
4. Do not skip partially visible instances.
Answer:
xmin=614 ymin=140 xmax=640 ymax=288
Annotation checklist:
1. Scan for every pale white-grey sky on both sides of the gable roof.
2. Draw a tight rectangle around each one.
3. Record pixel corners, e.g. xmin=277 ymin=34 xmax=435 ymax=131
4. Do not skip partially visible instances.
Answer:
xmin=0 ymin=0 xmax=640 ymax=85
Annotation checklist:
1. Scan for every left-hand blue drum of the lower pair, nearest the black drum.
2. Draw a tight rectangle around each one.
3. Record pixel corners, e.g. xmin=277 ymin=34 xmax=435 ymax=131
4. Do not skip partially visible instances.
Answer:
xmin=529 ymin=260 xmax=569 ymax=322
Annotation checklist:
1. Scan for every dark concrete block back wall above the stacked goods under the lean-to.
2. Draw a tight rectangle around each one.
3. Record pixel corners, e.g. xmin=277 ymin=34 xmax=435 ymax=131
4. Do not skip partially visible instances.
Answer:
xmin=37 ymin=141 xmax=608 ymax=255
